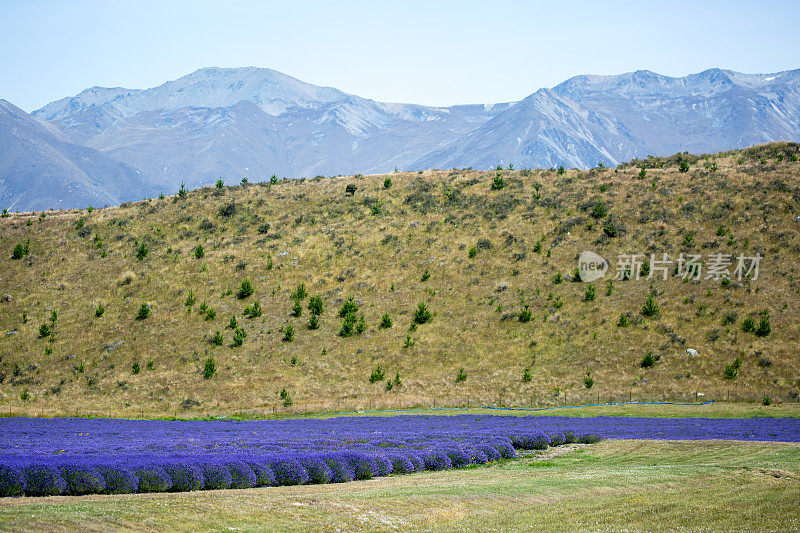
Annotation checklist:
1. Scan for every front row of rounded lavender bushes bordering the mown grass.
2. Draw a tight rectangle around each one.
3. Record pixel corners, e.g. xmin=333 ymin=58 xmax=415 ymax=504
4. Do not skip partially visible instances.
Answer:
xmin=0 ymin=431 xmax=599 ymax=496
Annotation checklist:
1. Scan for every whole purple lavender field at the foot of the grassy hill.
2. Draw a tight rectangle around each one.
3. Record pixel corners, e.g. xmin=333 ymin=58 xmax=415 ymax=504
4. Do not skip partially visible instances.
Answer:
xmin=0 ymin=415 xmax=800 ymax=496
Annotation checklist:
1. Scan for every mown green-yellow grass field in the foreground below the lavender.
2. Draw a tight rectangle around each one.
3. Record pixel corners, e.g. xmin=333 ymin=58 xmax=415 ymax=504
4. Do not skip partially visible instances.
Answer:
xmin=0 ymin=441 xmax=800 ymax=531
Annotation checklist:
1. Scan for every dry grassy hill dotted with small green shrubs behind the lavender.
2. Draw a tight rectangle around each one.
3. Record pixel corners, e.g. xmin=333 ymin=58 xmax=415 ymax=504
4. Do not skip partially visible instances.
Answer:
xmin=0 ymin=143 xmax=800 ymax=416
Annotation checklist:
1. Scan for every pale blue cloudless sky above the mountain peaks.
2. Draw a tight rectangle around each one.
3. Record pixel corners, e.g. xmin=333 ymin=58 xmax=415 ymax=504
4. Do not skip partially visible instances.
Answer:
xmin=0 ymin=0 xmax=800 ymax=111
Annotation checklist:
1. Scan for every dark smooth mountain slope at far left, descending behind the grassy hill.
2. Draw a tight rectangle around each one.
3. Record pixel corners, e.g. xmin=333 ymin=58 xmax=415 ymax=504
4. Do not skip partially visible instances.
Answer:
xmin=0 ymin=100 xmax=159 ymax=211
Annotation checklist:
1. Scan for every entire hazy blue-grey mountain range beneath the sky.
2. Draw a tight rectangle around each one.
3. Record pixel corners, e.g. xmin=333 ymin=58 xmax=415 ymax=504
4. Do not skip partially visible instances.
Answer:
xmin=0 ymin=67 xmax=800 ymax=210
